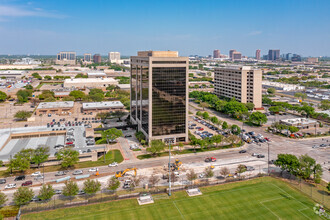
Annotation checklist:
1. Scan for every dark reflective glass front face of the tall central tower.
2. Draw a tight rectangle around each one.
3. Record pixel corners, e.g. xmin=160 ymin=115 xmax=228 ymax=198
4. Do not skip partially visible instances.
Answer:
xmin=152 ymin=67 xmax=186 ymax=136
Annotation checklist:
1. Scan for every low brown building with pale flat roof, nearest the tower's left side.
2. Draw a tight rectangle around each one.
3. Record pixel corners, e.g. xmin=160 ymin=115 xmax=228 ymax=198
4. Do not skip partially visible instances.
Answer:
xmin=82 ymin=101 xmax=125 ymax=113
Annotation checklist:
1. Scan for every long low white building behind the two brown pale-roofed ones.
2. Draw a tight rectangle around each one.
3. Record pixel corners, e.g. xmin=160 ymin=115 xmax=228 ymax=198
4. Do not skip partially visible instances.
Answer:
xmin=63 ymin=78 xmax=118 ymax=90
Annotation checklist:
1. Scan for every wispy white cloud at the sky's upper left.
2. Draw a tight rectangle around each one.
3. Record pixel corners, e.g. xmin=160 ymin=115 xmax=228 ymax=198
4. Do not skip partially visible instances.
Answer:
xmin=0 ymin=5 xmax=66 ymax=21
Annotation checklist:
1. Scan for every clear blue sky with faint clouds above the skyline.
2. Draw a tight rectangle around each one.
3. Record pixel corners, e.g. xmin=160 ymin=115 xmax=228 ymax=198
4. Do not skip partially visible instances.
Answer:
xmin=0 ymin=0 xmax=330 ymax=57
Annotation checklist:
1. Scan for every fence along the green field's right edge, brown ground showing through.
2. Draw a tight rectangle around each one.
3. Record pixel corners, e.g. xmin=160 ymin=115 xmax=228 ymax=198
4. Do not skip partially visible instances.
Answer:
xmin=271 ymin=172 xmax=330 ymax=209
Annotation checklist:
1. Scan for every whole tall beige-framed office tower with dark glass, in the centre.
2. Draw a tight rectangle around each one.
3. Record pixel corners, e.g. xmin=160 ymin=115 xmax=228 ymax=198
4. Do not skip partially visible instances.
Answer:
xmin=130 ymin=51 xmax=189 ymax=142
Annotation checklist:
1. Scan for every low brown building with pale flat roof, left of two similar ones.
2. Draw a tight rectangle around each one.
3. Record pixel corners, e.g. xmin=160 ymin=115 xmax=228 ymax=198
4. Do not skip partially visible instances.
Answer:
xmin=36 ymin=101 xmax=74 ymax=115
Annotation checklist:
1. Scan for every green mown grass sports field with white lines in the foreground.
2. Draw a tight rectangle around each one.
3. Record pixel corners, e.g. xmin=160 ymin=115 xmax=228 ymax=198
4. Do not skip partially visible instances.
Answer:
xmin=22 ymin=177 xmax=320 ymax=220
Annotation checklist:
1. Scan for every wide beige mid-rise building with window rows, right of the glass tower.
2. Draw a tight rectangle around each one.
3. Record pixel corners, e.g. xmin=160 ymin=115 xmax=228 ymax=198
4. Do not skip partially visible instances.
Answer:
xmin=214 ymin=66 xmax=262 ymax=109
